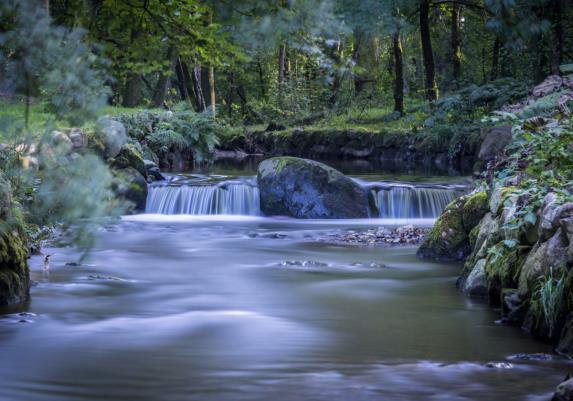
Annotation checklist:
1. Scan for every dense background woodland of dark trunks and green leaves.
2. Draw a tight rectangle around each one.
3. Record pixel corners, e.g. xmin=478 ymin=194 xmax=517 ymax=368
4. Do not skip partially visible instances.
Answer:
xmin=2 ymin=0 xmax=573 ymax=124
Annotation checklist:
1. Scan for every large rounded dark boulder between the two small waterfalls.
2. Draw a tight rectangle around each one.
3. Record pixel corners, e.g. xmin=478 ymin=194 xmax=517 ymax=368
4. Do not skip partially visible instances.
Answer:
xmin=257 ymin=157 xmax=369 ymax=219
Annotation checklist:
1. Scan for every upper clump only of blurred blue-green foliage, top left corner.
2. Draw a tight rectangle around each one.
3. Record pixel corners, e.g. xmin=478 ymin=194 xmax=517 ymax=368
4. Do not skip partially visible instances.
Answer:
xmin=0 ymin=0 xmax=106 ymax=125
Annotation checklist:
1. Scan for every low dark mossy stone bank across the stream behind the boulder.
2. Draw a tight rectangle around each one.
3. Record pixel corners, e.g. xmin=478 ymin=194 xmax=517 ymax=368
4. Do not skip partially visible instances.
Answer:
xmin=218 ymin=126 xmax=478 ymax=171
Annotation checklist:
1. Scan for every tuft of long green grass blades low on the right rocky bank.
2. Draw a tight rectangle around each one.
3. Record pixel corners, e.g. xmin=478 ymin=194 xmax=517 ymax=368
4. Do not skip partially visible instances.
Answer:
xmin=531 ymin=267 xmax=566 ymax=337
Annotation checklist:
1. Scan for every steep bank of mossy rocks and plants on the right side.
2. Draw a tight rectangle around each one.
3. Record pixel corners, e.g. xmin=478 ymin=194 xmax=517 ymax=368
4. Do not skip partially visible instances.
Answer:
xmin=418 ymin=69 xmax=573 ymax=400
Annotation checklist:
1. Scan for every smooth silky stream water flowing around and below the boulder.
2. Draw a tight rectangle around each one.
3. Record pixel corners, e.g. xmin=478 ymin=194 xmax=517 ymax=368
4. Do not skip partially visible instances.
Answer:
xmin=0 ymin=158 xmax=572 ymax=401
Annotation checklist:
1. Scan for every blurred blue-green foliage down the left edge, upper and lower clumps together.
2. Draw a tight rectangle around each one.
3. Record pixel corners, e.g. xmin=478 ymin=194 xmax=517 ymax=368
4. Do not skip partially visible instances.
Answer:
xmin=0 ymin=0 xmax=121 ymax=256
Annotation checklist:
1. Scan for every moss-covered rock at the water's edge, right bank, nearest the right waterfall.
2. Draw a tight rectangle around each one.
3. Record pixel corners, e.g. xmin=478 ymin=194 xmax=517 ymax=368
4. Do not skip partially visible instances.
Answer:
xmin=417 ymin=192 xmax=487 ymax=261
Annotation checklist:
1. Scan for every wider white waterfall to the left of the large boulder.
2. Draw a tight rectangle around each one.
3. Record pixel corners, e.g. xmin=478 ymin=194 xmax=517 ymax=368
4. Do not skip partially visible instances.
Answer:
xmin=145 ymin=182 xmax=261 ymax=216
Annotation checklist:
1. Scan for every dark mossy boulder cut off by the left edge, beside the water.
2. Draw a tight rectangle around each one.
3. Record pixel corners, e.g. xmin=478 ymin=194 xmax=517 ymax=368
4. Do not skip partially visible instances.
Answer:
xmin=0 ymin=176 xmax=30 ymax=305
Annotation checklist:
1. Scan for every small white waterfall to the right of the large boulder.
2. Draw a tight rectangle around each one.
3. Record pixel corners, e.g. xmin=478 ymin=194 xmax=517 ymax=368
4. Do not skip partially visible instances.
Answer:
xmin=372 ymin=186 xmax=461 ymax=219
